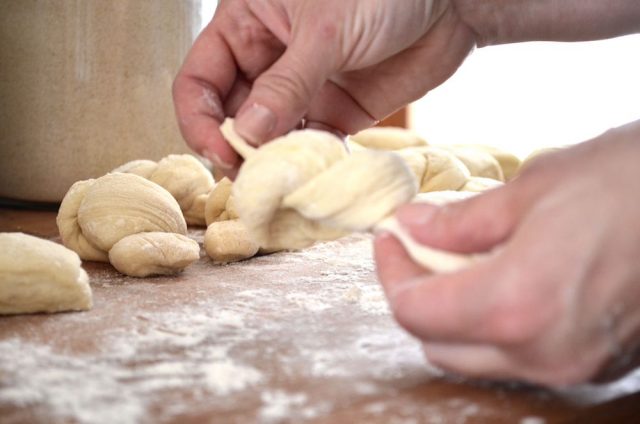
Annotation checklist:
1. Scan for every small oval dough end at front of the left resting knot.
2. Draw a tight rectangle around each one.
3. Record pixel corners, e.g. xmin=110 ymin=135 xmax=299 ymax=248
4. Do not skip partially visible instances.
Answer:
xmin=109 ymin=232 xmax=200 ymax=277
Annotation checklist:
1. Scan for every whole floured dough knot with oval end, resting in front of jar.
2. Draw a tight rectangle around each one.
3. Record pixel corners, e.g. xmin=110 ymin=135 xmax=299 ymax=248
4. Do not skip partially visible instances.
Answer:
xmin=56 ymin=173 xmax=198 ymax=276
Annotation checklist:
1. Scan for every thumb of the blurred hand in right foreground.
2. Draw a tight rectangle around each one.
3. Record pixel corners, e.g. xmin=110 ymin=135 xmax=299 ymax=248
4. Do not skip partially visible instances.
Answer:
xmin=397 ymin=181 xmax=529 ymax=253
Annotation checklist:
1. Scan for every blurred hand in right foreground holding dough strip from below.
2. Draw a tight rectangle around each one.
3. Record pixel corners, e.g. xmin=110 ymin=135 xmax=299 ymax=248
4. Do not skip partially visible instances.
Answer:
xmin=375 ymin=121 xmax=640 ymax=386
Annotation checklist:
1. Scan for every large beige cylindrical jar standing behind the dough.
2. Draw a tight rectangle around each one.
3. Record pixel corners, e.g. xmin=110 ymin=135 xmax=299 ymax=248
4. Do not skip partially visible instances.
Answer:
xmin=0 ymin=0 xmax=215 ymax=202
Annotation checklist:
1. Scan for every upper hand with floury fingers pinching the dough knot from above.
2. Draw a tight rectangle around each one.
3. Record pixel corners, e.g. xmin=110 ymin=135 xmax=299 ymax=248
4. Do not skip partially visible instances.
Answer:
xmin=173 ymin=0 xmax=474 ymax=174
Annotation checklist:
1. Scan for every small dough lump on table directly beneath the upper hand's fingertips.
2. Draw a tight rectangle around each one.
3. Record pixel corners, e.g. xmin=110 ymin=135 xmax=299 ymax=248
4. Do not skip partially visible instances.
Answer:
xmin=204 ymin=219 xmax=260 ymax=263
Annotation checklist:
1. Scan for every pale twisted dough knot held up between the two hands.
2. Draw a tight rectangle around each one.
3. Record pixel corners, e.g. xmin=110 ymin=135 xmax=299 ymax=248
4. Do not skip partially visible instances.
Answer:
xmin=221 ymin=120 xmax=417 ymax=250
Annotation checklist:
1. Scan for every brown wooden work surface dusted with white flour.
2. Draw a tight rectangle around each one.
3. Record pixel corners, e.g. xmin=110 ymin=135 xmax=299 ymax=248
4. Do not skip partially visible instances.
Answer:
xmin=0 ymin=209 xmax=640 ymax=424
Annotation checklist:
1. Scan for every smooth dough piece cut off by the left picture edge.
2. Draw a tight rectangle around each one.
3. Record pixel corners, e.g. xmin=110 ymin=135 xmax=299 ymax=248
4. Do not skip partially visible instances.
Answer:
xmin=0 ymin=233 xmax=92 ymax=315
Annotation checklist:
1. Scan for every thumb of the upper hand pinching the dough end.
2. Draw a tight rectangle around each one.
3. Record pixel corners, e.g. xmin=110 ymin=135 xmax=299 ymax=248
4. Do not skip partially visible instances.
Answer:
xmin=235 ymin=29 xmax=335 ymax=145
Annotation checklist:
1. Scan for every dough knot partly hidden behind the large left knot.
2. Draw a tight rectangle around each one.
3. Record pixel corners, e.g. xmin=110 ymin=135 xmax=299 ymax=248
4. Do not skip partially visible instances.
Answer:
xmin=112 ymin=154 xmax=214 ymax=225
